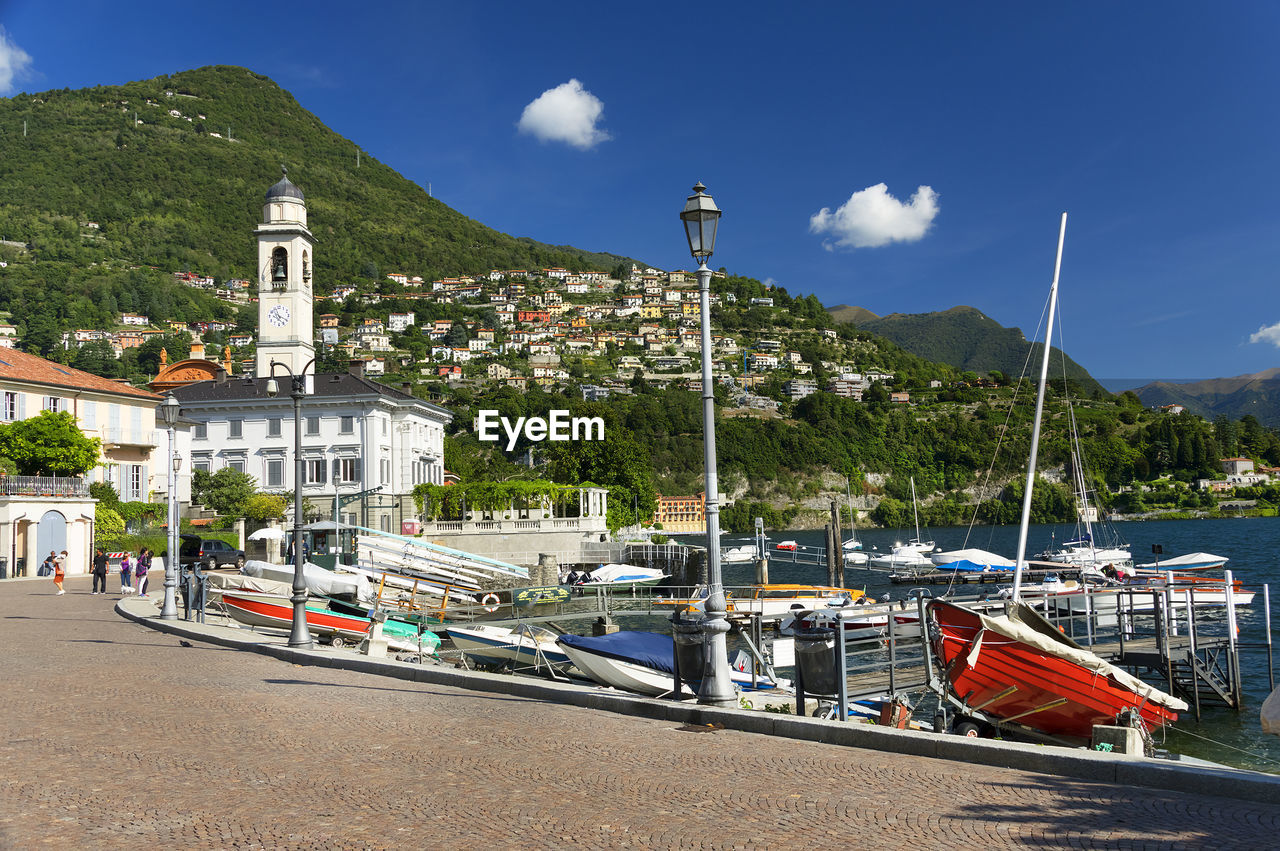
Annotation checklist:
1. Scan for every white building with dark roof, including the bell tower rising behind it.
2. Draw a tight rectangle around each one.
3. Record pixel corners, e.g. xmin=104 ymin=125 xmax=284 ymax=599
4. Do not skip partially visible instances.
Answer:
xmin=173 ymin=168 xmax=452 ymax=532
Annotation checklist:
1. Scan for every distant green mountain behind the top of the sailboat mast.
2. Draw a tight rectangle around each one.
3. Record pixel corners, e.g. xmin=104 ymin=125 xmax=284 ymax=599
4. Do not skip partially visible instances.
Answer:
xmin=842 ymin=306 xmax=1106 ymax=395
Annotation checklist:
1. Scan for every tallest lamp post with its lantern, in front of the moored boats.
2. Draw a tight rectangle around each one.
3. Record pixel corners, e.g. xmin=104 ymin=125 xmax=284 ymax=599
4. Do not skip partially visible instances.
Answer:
xmin=680 ymin=182 xmax=735 ymax=706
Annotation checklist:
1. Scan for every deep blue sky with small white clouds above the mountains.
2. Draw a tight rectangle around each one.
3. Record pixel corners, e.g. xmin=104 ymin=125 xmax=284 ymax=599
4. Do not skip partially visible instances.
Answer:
xmin=0 ymin=0 xmax=1280 ymax=379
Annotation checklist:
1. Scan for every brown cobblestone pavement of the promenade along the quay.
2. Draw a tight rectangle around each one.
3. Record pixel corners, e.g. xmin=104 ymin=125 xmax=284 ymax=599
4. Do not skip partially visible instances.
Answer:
xmin=0 ymin=577 xmax=1280 ymax=850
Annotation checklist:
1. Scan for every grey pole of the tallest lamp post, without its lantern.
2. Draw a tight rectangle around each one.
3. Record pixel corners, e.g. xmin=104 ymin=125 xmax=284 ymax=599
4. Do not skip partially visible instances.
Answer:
xmin=698 ymin=260 xmax=735 ymax=706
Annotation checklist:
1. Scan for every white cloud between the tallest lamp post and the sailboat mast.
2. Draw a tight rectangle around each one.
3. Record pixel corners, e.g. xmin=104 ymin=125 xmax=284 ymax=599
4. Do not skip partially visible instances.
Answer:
xmin=809 ymin=183 xmax=938 ymax=251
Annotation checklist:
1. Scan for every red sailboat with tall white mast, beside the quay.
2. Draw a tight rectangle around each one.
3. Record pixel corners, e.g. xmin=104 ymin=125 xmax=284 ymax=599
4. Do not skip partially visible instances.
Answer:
xmin=927 ymin=212 xmax=1187 ymax=741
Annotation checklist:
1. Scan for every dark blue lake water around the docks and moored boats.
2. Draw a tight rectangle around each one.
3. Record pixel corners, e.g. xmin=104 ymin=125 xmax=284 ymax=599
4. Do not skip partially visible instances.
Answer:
xmin=680 ymin=517 xmax=1280 ymax=774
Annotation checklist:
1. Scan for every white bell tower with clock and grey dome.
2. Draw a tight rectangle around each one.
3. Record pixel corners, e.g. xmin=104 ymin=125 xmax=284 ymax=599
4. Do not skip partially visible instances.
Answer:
xmin=253 ymin=166 xmax=315 ymax=378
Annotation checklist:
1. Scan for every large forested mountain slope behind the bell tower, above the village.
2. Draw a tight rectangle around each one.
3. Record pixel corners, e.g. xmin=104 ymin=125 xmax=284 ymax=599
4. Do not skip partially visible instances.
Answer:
xmin=0 ymin=67 xmax=630 ymax=292
